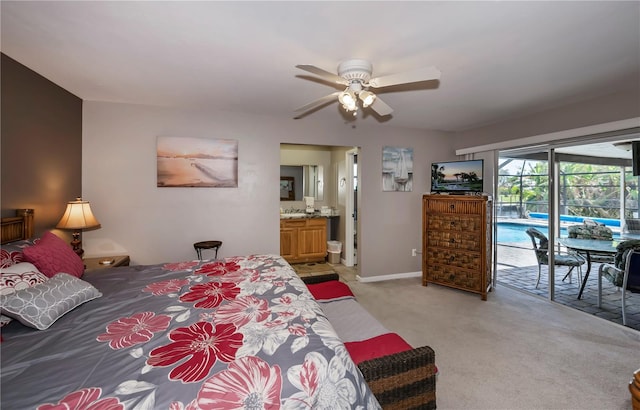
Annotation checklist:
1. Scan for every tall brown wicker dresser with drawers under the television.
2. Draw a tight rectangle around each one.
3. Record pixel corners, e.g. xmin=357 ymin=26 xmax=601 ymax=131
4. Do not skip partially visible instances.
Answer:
xmin=422 ymin=194 xmax=492 ymax=300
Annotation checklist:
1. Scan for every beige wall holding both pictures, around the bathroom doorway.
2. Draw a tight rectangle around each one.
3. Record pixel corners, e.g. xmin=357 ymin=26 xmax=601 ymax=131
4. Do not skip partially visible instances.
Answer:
xmin=83 ymin=102 xmax=455 ymax=277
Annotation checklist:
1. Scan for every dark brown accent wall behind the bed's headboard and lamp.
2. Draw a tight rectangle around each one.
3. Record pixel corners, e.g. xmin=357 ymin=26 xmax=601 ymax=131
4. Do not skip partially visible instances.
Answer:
xmin=0 ymin=54 xmax=82 ymax=236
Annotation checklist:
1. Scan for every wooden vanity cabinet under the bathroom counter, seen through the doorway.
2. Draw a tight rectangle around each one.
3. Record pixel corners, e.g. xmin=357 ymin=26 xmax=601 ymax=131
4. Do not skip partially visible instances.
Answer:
xmin=280 ymin=218 xmax=327 ymax=263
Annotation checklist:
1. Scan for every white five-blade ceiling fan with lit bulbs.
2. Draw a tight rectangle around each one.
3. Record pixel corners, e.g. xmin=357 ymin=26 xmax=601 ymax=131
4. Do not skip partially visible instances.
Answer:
xmin=295 ymin=59 xmax=440 ymax=118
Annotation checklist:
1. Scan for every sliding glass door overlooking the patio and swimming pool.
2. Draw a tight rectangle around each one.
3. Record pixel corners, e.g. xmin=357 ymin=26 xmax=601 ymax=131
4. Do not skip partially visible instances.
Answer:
xmin=494 ymin=135 xmax=639 ymax=315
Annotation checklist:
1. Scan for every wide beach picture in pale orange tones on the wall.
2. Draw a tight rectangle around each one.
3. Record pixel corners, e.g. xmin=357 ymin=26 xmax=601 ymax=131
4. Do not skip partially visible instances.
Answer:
xmin=156 ymin=137 xmax=238 ymax=188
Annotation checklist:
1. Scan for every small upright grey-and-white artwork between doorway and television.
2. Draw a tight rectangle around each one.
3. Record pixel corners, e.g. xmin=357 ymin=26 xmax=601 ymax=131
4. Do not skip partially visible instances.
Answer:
xmin=382 ymin=147 xmax=413 ymax=192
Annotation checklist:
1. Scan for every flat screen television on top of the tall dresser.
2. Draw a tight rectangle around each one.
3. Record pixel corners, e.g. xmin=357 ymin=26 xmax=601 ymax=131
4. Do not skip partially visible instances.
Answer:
xmin=431 ymin=159 xmax=484 ymax=194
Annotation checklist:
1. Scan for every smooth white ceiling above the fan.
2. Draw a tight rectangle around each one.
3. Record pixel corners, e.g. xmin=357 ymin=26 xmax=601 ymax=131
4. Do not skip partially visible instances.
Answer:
xmin=0 ymin=1 xmax=640 ymax=131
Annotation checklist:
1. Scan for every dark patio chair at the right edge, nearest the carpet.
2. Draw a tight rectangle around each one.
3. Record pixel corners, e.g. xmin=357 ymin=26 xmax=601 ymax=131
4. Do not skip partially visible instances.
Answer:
xmin=598 ymin=239 xmax=640 ymax=325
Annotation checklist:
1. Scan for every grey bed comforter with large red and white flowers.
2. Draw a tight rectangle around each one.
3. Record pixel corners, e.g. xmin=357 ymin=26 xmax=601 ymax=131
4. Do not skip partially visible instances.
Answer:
xmin=0 ymin=255 xmax=380 ymax=410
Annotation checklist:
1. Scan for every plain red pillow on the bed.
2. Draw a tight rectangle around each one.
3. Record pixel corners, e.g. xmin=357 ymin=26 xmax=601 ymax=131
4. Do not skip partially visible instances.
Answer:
xmin=22 ymin=232 xmax=84 ymax=278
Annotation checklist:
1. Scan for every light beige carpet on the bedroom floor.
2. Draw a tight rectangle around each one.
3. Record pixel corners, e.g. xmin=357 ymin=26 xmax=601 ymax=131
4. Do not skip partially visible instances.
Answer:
xmin=348 ymin=278 xmax=640 ymax=410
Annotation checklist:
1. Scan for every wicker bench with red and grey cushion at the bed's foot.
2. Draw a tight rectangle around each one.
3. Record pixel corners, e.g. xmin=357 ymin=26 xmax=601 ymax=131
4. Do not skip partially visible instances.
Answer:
xmin=302 ymin=274 xmax=437 ymax=410
